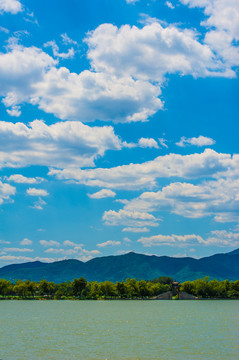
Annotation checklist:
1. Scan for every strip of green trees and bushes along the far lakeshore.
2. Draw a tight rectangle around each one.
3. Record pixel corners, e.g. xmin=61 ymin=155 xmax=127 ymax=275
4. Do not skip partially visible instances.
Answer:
xmin=0 ymin=276 xmax=239 ymax=300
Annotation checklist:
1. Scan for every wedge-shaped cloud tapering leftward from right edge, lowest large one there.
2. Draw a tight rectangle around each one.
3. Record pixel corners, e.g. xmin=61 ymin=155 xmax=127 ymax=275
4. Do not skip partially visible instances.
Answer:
xmin=124 ymin=178 xmax=239 ymax=222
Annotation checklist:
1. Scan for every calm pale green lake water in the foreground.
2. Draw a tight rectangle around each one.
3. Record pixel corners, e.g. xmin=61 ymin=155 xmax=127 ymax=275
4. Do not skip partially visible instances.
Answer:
xmin=0 ymin=300 xmax=239 ymax=360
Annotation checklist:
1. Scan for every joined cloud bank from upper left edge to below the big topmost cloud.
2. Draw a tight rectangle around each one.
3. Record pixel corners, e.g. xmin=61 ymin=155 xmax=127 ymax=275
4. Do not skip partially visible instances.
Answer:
xmin=0 ymin=42 xmax=163 ymax=122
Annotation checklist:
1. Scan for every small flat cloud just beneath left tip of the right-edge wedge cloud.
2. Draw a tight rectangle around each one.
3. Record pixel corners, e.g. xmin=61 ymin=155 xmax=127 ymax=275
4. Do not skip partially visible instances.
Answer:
xmin=103 ymin=210 xmax=158 ymax=227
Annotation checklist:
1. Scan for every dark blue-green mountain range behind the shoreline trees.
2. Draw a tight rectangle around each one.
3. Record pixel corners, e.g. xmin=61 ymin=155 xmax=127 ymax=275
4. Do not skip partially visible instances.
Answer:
xmin=0 ymin=249 xmax=239 ymax=283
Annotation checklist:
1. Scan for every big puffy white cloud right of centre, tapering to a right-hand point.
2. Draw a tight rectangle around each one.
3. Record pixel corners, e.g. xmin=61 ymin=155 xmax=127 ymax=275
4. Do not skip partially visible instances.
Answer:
xmin=86 ymin=22 xmax=230 ymax=84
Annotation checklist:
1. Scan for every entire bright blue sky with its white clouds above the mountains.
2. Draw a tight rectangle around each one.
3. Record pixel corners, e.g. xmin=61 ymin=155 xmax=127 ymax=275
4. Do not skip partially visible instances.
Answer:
xmin=0 ymin=0 xmax=239 ymax=266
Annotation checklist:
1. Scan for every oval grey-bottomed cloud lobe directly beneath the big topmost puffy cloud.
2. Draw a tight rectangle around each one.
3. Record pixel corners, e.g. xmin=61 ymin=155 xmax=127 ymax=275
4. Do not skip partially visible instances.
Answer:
xmin=34 ymin=68 xmax=163 ymax=122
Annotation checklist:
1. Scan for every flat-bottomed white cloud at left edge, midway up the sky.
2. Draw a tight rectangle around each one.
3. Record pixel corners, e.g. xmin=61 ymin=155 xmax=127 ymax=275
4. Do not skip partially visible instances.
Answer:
xmin=0 ymin=120 xmax=122 ymax=168
